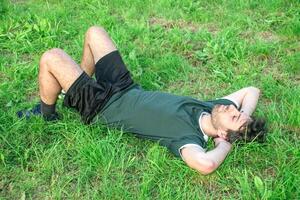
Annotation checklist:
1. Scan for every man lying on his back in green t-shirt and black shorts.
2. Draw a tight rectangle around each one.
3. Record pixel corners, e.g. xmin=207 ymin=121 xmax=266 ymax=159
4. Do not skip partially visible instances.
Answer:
xmin=18 ymin=26 xmax=268 ymax=174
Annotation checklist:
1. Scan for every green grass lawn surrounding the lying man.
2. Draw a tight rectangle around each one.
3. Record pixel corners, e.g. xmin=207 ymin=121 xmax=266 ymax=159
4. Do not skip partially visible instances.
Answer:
xmin=0 ymin=0 xmax=300 ymax=200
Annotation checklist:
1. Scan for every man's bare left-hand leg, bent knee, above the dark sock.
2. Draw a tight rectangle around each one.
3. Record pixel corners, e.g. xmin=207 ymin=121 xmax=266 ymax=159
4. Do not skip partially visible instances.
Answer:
xmin=39 ymin=49 xmax=82 ymax=105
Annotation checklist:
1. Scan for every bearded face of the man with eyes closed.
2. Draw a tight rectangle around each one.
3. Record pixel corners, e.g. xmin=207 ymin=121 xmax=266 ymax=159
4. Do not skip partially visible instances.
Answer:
xmin=212 ymin=105 xmax=248 ymax=136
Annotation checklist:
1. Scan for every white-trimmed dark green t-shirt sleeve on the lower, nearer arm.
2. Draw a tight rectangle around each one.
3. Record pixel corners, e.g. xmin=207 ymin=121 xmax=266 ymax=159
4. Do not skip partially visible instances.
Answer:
xmin=167 ymin=135 xmax=207 ymax=158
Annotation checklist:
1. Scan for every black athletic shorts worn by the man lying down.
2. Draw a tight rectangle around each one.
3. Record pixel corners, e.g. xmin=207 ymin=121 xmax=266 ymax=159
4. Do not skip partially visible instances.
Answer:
xmin=64 ymin=51 xmax=133 ymax=124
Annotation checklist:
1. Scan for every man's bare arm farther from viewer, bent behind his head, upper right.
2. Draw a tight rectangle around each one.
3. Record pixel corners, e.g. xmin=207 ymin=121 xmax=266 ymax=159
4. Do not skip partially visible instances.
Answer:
xmin=223 ymin=87 xmax=260 ymax=116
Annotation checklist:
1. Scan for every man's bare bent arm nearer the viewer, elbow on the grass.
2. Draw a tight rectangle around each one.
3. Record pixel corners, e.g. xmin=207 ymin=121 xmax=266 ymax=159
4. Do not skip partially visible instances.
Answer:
xmin=181 ymin=138 xmax=231 ymax=175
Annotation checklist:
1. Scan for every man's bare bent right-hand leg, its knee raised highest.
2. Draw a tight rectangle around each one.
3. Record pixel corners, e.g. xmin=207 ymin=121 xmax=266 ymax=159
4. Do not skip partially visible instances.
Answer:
xmin=81 ymin=26 xmax=117 ymax=76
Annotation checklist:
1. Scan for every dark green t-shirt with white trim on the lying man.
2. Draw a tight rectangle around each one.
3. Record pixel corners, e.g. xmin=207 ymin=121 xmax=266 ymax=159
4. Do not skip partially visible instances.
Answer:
xmin=98 ymin=84 xmax=236 ymax=159
